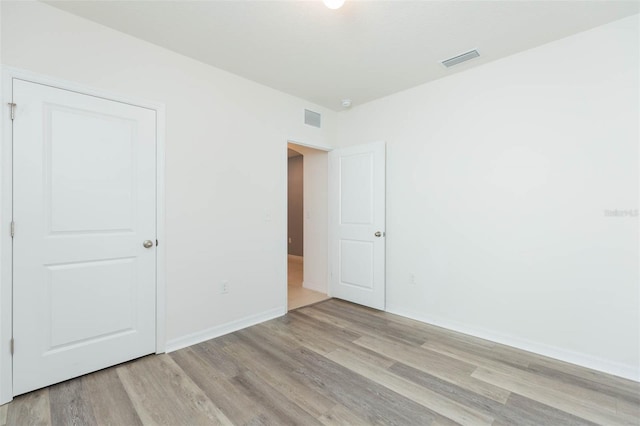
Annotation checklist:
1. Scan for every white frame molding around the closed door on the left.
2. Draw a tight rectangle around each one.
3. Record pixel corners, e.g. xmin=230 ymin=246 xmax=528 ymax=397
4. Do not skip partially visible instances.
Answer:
xmin=0 ymin=66 xmax=166 ymax=404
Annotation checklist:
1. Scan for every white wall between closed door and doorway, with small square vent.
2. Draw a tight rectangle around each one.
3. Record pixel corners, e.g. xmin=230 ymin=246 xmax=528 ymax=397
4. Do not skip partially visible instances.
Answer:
xmin=2 ymin=1 xmax=335 ymax=347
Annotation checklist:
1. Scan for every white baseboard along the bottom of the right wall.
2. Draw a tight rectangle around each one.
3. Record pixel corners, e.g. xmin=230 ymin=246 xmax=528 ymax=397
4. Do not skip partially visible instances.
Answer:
xmin=386 ymin=307 xmax=640 ymax=382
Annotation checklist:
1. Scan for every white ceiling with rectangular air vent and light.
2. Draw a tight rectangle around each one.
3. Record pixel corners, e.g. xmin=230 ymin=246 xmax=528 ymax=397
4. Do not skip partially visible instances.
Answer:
xmin=48 ymin=0 xmax=640 ymax=110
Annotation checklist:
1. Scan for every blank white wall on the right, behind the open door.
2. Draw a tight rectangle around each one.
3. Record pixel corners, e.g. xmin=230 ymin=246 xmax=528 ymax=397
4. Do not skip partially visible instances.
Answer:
xmin=337 ymin=16 xmax=640 ymax=380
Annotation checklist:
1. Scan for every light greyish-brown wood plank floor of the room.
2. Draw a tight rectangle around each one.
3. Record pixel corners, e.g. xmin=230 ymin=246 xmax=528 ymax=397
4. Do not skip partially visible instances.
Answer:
xmin=0 ymin=299 xmax=640 ymax=425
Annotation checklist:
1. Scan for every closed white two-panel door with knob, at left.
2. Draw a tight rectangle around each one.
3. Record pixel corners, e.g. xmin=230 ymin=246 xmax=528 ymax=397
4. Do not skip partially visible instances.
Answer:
xmin=13 ymin=79 xmax=156 ymax=395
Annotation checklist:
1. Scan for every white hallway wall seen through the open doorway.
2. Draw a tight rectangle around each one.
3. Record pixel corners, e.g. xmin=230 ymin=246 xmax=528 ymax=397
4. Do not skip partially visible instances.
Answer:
xmin=291 ymin=145 xmax=329 ymax=294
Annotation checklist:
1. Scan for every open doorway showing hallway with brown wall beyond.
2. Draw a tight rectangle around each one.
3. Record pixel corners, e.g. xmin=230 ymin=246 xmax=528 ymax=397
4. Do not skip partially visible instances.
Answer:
xmin=287 ymin=143 xmax=328 ymax=310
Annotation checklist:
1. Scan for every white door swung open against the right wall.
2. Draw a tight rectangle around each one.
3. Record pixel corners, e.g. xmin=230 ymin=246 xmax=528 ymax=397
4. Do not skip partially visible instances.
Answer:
xmin=329 ymin=142 xmax=385 ymax=309
